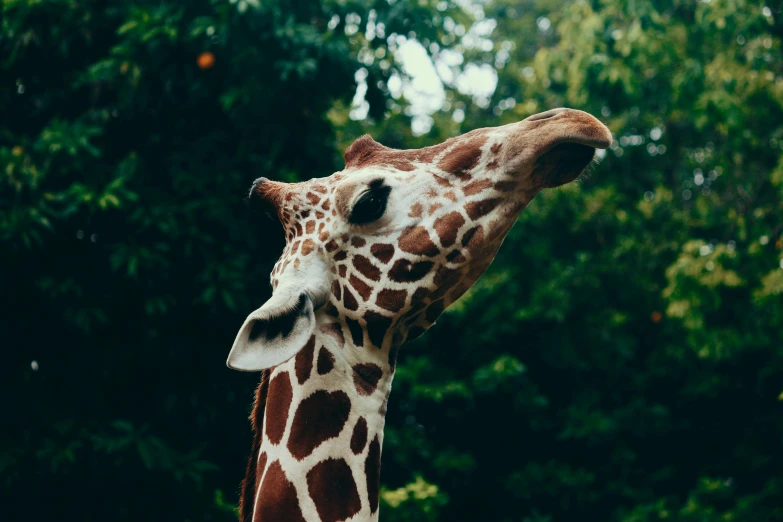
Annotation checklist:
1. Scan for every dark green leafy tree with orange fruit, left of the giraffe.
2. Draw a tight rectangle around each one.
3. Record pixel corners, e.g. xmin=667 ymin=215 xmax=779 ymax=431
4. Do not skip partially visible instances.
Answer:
xmin=0 ymin=0 xmax=468 ymax=520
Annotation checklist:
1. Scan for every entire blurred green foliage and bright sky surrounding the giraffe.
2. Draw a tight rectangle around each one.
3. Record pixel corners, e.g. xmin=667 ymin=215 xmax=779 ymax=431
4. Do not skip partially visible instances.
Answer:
xmin=0 ymin=0 xmax=783 ymax=522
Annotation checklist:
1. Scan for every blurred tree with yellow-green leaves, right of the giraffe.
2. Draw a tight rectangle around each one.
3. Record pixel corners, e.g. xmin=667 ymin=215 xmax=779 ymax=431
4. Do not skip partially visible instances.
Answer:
xmin=362 ymin=1 xmax=783 ymax=522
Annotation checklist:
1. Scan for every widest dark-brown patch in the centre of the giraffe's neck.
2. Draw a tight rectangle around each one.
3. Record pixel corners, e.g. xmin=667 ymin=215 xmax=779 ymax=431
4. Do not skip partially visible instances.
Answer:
xmin=288 ymin=390 xmax=351 ymax=460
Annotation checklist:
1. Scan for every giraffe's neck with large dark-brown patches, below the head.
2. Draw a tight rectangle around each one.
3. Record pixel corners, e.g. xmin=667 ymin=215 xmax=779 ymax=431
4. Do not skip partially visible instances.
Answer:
xmin=242 ymin=321 xmax=393 ymax=522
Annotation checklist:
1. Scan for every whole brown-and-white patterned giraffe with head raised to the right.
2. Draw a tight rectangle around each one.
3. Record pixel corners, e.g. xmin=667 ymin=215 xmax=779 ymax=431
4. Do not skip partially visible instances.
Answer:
xmin=227 ymin=108 xmax=612 ymax=522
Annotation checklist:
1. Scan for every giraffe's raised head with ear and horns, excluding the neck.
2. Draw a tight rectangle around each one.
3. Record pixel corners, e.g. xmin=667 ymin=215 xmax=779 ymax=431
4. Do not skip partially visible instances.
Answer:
xmin=228 ymin=109 xmax=612 ymax=370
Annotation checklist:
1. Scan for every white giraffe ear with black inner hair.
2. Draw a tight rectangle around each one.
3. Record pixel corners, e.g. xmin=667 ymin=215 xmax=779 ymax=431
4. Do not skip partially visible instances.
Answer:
xmin=226 ymin=293 xmax=315 ymax=372
